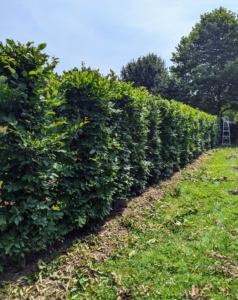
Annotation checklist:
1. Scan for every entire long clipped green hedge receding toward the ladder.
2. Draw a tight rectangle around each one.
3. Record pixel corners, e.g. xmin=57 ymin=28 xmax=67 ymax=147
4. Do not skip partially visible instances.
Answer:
xmin=0 ymin=40 xmax=219 ymax=269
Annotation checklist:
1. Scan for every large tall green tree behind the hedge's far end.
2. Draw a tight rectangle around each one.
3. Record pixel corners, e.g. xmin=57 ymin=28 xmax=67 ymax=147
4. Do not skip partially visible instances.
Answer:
xmin=171 ymin=7 xmax=238 ymax=114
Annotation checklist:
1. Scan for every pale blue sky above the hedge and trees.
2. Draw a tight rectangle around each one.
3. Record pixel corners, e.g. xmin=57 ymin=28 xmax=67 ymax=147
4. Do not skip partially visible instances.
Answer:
xmin=0 ymin=0 xmax=238 ymax=75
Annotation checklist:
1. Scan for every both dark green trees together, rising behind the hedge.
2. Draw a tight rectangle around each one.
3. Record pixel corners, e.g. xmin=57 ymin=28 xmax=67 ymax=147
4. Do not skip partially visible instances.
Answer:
xmin=121 ymin=7 xmax=238 ymax=115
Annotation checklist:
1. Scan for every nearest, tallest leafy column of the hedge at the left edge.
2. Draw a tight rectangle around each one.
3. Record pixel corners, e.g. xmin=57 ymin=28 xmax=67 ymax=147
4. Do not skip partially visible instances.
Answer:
xmin=0 ymin=40 xmax=66 ymax=270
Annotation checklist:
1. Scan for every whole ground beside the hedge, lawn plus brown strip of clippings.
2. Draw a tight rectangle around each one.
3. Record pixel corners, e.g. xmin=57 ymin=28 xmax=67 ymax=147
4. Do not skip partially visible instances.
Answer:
xmin=0 ymin=147 xmax=238 ymax=300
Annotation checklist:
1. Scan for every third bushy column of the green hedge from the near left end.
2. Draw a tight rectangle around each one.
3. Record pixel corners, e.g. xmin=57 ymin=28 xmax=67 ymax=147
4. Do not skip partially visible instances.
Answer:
xmin=105 ymin=78 xmax=149 ymax=200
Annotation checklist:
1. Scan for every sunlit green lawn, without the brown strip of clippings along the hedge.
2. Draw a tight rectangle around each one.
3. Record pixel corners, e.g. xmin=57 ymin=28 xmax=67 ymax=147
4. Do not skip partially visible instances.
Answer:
xmin=82 ymin=149 xmax=238 ymax=299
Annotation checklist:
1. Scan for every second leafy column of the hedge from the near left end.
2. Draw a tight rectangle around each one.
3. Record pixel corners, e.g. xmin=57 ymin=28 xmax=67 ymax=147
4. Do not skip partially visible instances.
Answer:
xmin=53 ymin=68 xmax=118 ymax=228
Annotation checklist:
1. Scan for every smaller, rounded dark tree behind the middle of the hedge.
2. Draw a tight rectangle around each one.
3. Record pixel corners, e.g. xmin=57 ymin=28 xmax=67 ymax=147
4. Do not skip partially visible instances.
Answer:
xmin=121 ymin=53 xmax=168 ymax=96
